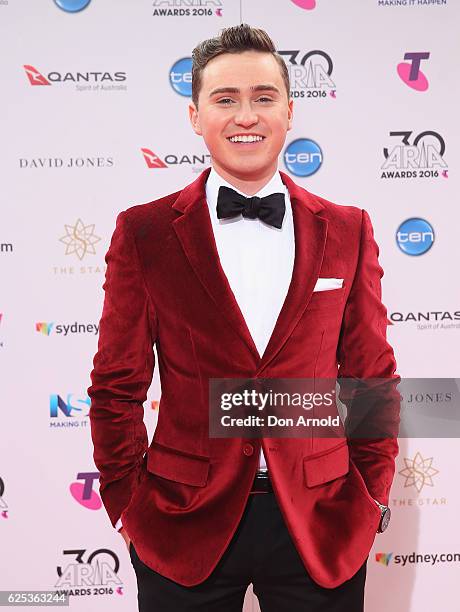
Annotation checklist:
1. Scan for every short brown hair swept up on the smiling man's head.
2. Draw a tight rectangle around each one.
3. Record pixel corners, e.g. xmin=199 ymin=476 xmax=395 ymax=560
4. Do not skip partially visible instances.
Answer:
xmin=192 ymin=23 xmax=291 ymax=108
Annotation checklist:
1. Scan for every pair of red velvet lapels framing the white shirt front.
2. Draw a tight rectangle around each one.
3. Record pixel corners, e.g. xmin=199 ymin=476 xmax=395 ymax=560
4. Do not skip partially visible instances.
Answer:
xmin=172 ymin=168 xmax=327 ymax=376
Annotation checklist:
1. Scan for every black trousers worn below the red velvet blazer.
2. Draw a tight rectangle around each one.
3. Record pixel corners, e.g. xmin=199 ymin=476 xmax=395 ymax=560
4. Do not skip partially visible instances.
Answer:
xmin=130 ymin=493 xmax=367 ymax=612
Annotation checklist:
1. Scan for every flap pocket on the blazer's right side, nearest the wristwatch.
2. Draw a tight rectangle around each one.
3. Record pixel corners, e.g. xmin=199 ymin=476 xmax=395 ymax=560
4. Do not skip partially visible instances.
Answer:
xmin=303 ymin=440 xmax=350 ymax=487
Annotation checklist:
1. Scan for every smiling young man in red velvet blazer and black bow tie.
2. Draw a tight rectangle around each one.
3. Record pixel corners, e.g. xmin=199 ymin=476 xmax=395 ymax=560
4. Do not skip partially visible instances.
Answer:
xmin=88 ymin=24 xmax=398 ymax=612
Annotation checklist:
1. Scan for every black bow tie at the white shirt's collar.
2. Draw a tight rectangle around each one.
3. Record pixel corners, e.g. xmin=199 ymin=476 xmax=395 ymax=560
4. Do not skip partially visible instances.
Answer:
xmin=216 ymin=185 xmax=286 ymax=229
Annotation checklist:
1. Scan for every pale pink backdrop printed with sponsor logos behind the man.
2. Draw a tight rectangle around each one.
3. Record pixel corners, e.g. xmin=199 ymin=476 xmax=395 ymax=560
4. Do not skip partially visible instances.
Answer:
xmin=0 ymin=0 xmax=460 ymax=612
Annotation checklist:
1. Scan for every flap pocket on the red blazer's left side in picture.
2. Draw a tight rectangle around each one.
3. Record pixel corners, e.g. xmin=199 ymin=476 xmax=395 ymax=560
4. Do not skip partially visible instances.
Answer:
xmin=147 ymin=442 xmax=209 ymax=487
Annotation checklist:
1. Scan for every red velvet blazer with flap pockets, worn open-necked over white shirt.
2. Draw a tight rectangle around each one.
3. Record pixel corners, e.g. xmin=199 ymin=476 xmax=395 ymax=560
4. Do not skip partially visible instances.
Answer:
xmin=88 ymin=169 xmax=398 ymax=588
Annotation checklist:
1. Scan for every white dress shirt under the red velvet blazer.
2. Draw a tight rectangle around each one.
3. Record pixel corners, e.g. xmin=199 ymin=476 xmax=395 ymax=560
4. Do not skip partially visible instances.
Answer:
xmin=115 ymin=168 xmax=295 ymax=530
